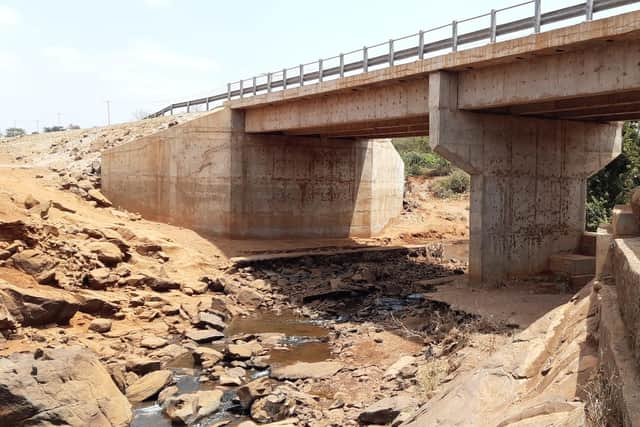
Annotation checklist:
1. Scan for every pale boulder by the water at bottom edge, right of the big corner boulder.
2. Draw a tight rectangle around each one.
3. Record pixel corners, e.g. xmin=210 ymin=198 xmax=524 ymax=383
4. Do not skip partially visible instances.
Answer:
xmin=162 ymin=390 xmax=223 ymax=425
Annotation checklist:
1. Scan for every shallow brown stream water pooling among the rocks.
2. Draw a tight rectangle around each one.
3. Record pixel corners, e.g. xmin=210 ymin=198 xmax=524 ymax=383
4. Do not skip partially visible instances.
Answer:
xmin=131 ymin=311 xmax=332 ymax=427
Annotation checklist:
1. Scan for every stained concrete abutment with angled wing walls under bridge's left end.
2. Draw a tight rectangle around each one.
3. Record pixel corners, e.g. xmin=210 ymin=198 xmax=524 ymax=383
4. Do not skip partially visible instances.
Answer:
xmin=102 ymin=109 xmax=404 ymax=238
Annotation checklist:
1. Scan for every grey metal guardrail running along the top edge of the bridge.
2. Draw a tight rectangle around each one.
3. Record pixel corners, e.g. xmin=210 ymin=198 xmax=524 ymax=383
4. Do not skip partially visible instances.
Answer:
xmin=148 ymin=0 xmax=640 ymax=118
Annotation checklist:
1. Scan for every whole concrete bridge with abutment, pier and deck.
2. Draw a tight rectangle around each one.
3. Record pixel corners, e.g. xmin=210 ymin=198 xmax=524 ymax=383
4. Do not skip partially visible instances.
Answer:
xmin=102 ymin=2 xmax=640 ymax=282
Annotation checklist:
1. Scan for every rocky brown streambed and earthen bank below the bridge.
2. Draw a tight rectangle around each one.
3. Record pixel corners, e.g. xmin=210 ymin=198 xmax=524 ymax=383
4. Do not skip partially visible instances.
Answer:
xmin=0 ymin=120 xmax=591 ymax=426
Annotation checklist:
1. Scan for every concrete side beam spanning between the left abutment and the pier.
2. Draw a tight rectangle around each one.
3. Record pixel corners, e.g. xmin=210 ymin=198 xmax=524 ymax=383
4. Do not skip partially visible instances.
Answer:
xmin=245 ymin=78 xmax=429 ymax=136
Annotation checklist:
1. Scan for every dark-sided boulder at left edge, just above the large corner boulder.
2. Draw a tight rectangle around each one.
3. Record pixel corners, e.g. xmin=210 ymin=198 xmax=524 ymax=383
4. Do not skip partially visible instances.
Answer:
xmin=0 ymin=279 xmax=79 ymax=326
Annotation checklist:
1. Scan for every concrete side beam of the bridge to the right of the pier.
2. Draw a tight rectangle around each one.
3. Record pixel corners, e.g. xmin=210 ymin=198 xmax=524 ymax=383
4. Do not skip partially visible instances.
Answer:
xmin=458 ymin=40 xmax=640 ymax=115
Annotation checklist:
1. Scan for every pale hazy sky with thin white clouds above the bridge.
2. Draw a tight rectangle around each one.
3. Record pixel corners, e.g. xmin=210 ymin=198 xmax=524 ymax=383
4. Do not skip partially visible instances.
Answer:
xmin=0 ymin=0 xmax=640 ymax=132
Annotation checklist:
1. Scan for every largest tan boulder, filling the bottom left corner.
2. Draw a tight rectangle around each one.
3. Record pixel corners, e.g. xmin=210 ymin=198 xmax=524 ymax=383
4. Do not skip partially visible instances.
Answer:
xmin=0 ymin=347 xmax=132 ymax=427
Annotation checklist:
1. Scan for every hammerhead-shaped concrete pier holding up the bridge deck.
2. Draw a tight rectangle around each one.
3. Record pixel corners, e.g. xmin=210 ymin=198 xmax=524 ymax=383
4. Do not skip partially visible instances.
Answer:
xmin=429 ymin=72 xmax=622 ymax=285
